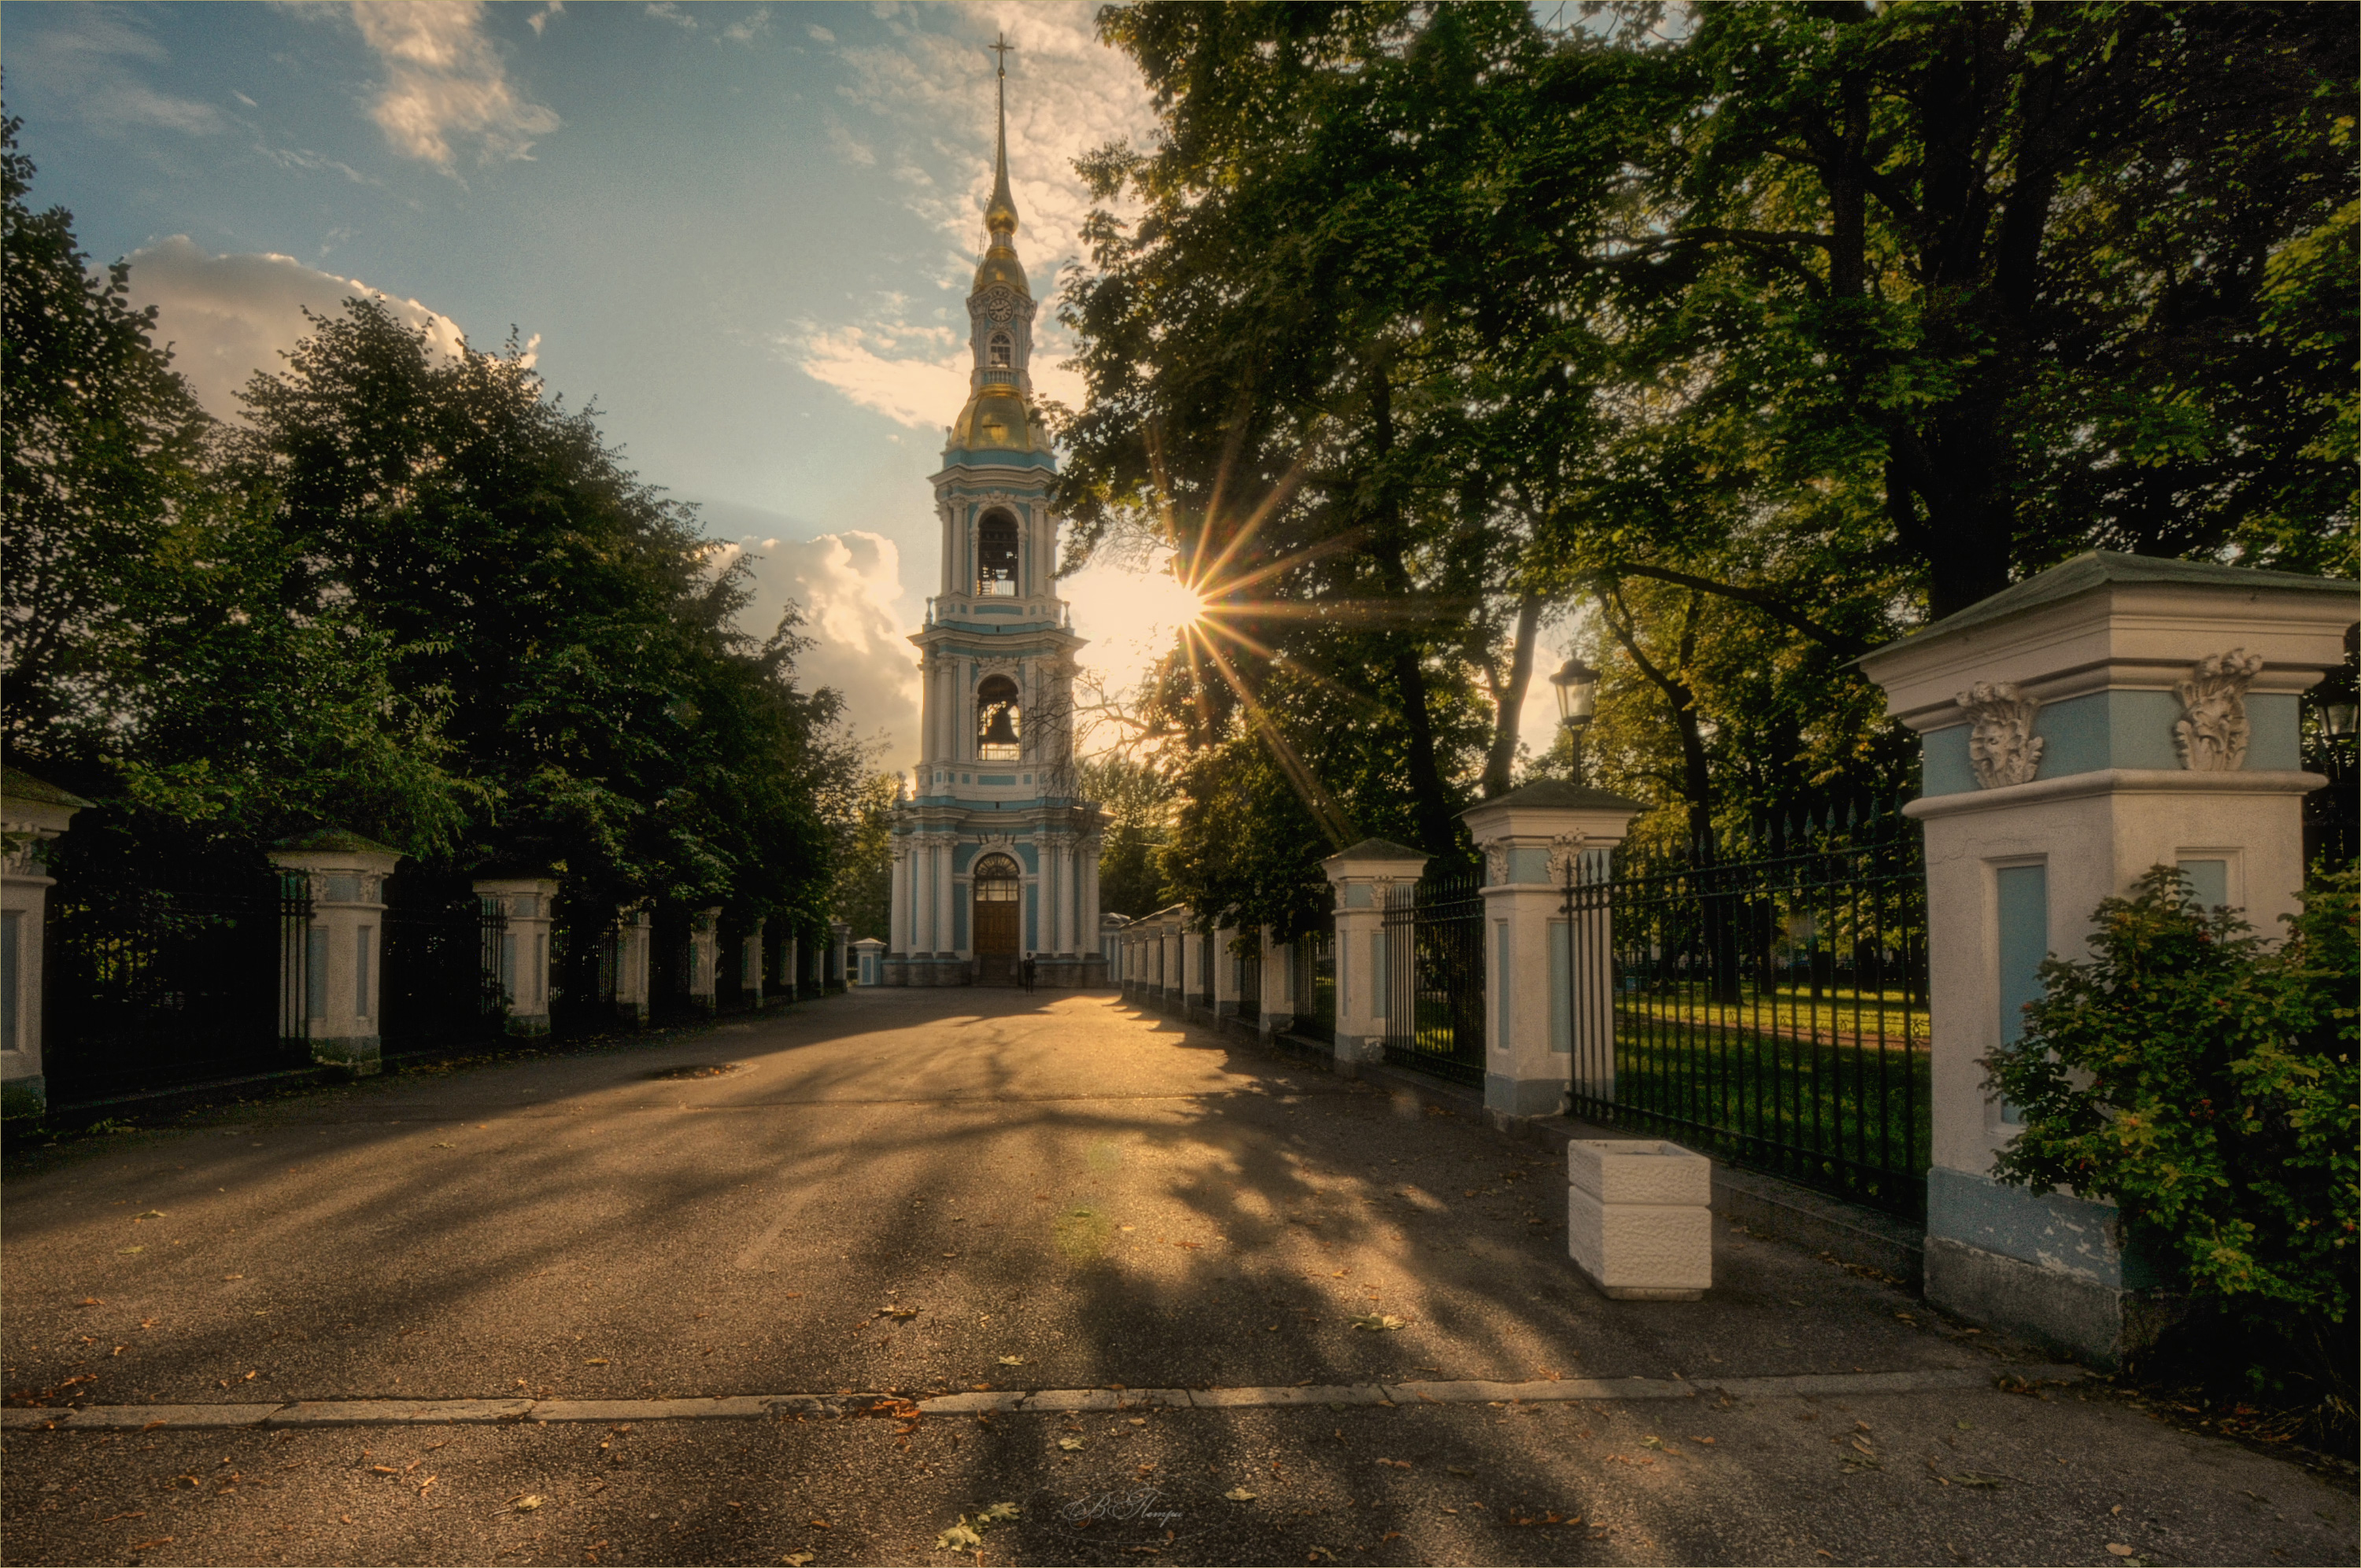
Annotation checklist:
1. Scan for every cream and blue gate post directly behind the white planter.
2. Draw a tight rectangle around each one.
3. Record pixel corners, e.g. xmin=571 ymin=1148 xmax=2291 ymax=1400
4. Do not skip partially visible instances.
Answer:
xmin=1459 ymin=779 xmax=1648 ymax=1127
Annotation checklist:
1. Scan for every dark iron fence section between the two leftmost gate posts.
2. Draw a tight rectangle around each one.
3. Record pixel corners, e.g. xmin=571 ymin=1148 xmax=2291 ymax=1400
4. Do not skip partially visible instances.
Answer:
xmin=42 ymin=840 xmax=326 ymax=1108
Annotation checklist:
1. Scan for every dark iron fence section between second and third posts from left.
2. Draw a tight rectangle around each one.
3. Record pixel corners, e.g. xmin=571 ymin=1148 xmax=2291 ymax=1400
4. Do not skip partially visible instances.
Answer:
xmin=378 ymin=869 xmax=508 ymax=1056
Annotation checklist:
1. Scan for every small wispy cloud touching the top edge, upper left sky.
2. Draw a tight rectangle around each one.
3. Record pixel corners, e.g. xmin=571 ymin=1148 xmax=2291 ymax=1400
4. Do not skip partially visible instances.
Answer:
xmin=352 ymin=0 xmax=562 ymax=170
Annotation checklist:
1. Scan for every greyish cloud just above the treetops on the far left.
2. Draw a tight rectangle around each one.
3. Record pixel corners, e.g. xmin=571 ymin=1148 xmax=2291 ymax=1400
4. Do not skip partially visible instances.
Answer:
xmin=127 ymin=234 xmax=470 ymax=420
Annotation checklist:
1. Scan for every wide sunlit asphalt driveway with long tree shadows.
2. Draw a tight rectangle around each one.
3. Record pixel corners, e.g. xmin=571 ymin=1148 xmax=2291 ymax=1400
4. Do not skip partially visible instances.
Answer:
xmin=0 ymin=990 xmax=2356 ymax=1563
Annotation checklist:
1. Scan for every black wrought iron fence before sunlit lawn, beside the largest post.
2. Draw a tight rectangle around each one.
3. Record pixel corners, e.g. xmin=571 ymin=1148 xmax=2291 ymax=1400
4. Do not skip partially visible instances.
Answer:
xmin=1554 ymin=803 xmax=1931 ymax=1216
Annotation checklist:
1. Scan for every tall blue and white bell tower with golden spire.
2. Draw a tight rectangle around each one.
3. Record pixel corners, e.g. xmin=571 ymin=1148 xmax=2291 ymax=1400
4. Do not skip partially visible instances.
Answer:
xmin=883 ymin=38 xmax=1107 ymax=985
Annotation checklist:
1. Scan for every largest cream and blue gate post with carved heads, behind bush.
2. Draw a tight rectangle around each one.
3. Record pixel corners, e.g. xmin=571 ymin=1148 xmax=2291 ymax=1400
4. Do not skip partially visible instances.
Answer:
xmin=1860 ymin=550 xmax=2356 ymax=1365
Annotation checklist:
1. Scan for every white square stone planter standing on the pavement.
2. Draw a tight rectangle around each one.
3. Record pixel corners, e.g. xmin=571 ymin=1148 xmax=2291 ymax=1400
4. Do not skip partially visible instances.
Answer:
xmin=1565 ymin=1138 xmax=1714 ymax=1301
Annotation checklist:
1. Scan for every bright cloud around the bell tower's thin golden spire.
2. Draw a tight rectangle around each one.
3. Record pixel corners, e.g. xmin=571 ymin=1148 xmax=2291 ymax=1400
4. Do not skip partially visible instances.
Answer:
xmin=777 ymin=0 xmax=1155 ymax=427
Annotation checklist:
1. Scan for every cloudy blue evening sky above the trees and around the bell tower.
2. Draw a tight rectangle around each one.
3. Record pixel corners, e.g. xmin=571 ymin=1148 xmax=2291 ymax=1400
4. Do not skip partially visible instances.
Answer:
xmin=13 ymin=0 xmax=1554 ymax=767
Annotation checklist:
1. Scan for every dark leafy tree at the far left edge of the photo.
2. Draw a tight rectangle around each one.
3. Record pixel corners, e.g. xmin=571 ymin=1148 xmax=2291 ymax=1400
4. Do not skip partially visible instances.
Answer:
xmin=0 ymin=116 xmax=465 ymax=853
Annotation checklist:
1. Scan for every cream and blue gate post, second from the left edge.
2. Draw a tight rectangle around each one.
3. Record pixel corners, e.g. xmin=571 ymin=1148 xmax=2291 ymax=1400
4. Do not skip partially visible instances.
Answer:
xmin=272 ymin=829 xmax=401 ymax=1077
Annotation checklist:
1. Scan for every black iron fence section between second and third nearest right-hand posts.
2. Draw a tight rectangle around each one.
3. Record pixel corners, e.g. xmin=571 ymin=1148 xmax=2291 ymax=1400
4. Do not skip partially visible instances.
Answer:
xmin=1374 ymin=867 xmax=1485 ymax=1087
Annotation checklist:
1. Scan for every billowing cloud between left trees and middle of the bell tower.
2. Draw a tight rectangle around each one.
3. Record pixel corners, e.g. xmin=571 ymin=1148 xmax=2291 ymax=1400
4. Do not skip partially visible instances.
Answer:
xmin=699 ymin=500 xmax=918 ymax=755
